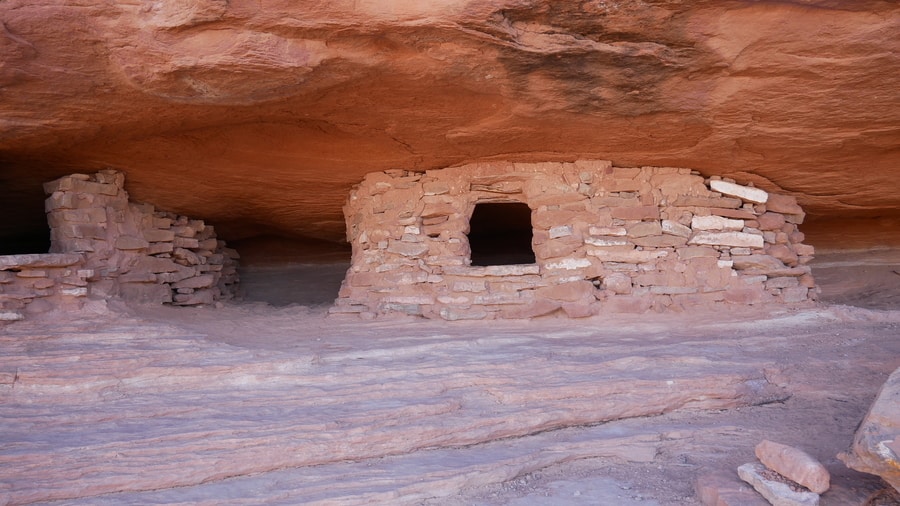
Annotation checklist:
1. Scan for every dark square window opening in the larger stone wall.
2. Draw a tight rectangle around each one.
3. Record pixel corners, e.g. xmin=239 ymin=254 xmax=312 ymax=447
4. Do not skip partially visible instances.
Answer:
xmin=469 ymin=202 xmax=535 ymax=266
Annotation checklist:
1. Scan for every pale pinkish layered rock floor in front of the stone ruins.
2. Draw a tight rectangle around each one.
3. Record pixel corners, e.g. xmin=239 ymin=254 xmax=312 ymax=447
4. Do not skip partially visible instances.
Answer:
xmin=0 ymin=251 xmax=900 ymax=506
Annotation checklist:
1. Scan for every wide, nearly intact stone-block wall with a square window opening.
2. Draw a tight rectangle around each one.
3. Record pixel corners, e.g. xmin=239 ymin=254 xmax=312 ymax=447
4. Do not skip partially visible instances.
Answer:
xmin=331 ymin=160 xmax=816 ymax=320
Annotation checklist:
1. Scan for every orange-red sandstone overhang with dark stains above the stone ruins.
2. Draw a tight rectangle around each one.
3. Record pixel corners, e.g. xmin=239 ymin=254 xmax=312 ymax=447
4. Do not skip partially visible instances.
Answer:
xmin=0 ymin=0 xmax=900 ymax=250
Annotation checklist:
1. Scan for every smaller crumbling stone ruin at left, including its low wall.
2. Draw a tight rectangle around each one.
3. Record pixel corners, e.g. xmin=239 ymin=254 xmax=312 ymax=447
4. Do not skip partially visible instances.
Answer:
xmin=0 ymin=170 xmax=237 ymax=320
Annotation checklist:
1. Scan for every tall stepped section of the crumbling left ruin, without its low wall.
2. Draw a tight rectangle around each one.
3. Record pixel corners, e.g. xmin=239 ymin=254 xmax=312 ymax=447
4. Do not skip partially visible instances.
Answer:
xmin=44 ymin=170 xmax=238 ymax=305
